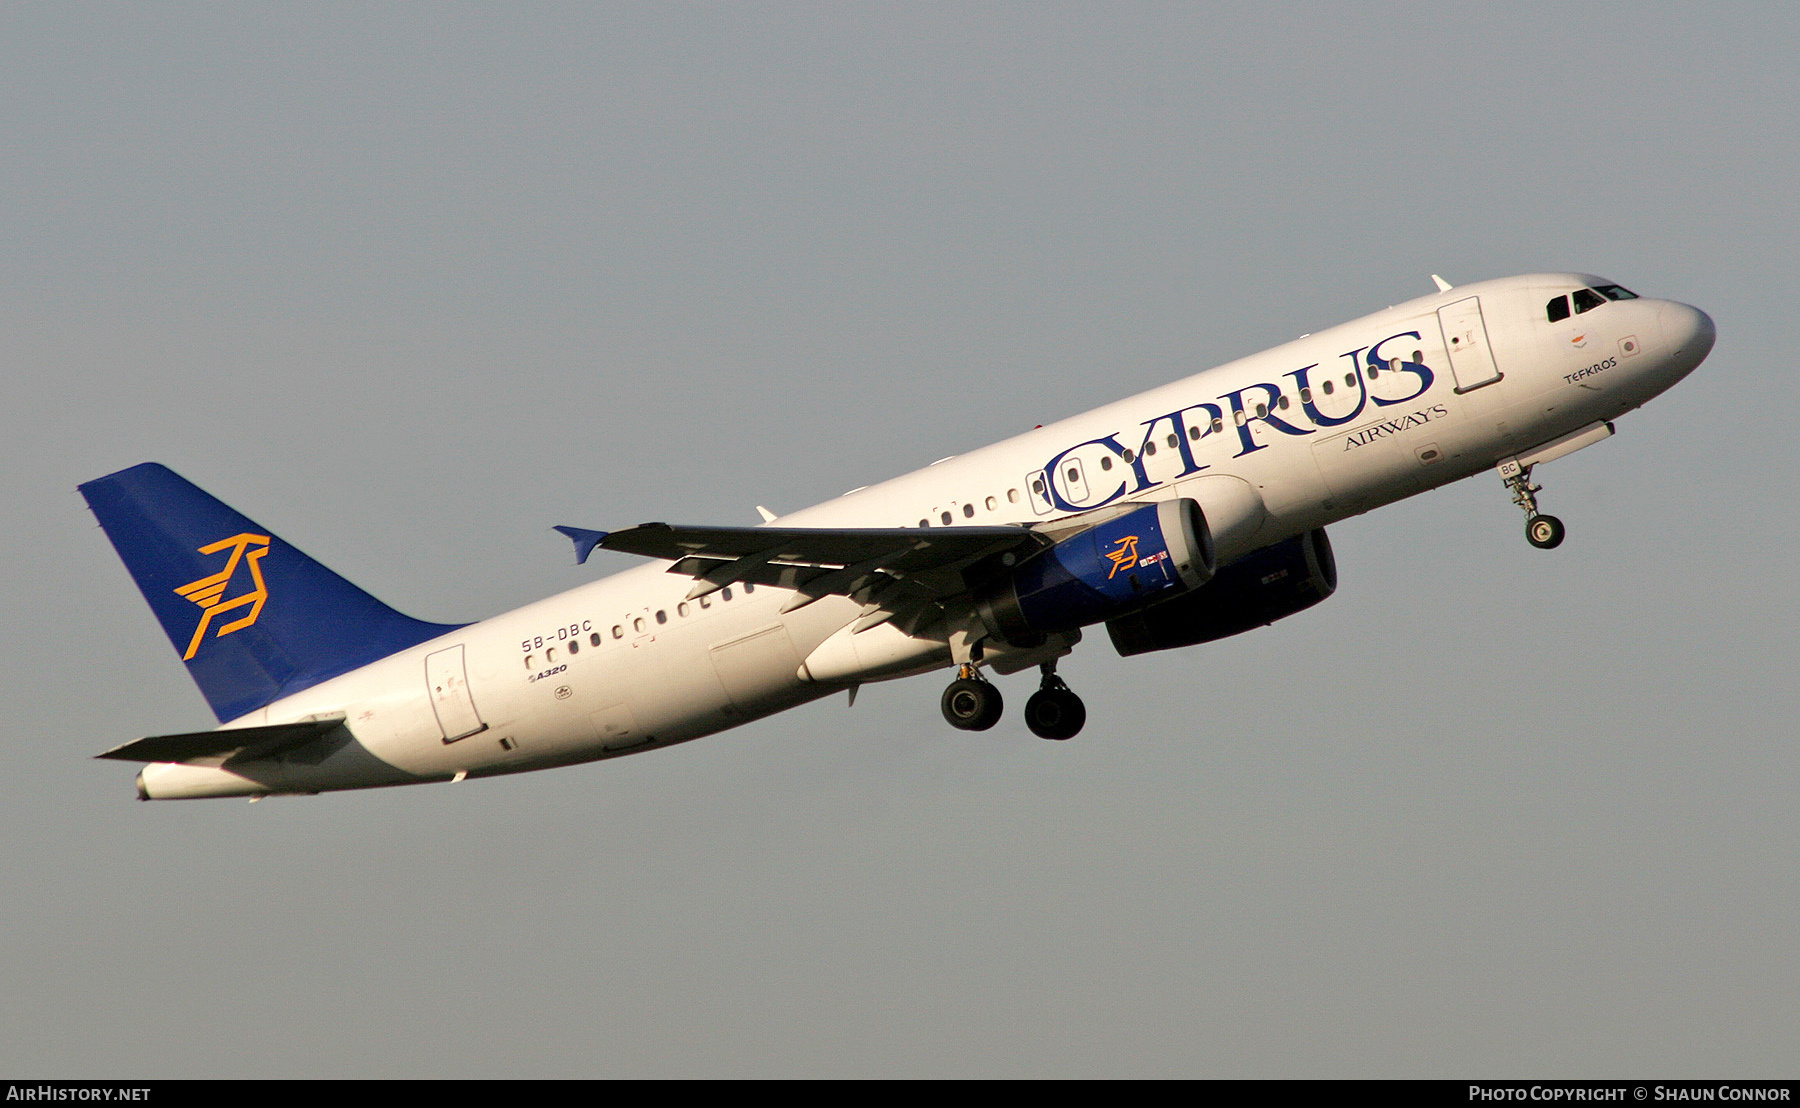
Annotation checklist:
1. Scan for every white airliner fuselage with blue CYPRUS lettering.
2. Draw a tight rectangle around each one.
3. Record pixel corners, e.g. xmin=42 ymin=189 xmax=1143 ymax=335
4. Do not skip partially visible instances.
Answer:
xmin=140 ymin=273 xmax=1712 ymax=797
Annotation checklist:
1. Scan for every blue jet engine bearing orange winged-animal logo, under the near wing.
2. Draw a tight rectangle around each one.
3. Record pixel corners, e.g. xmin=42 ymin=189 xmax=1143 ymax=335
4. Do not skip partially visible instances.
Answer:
xmin=976 ymin=498 xmax=1213 ymax=646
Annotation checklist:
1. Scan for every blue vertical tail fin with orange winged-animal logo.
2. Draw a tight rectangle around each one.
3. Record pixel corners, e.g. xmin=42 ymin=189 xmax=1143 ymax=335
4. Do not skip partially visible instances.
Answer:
xmin=81 ymin=462 xmax=461 ymax=721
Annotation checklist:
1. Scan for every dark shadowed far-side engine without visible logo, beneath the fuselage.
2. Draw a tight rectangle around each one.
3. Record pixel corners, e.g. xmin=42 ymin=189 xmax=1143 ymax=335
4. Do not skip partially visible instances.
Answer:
xmin=1107 ymin=529 xmax=1337 ymax=657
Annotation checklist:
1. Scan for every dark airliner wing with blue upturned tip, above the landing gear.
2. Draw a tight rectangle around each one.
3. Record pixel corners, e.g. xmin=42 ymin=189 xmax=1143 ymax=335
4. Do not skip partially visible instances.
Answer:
xmin=556 ymin=523 xmax=1053 ymax=635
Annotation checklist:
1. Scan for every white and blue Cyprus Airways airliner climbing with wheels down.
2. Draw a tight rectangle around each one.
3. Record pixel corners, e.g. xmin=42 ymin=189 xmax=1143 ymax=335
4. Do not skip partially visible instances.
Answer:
xmin=81 ymin=273 xmax=1715 ymax=800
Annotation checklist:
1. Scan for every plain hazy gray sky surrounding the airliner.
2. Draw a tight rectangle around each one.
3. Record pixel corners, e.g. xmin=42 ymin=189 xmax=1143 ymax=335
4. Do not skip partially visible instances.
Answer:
xmin=0 ymin=2 xmax=1800 ymax=1077
